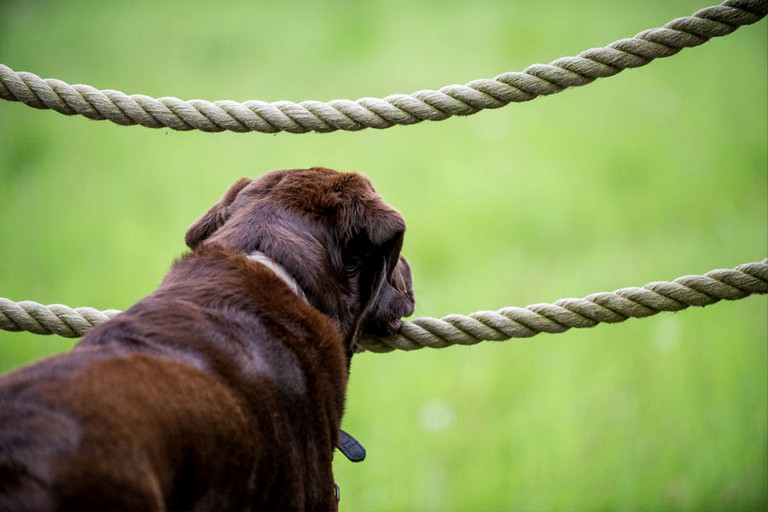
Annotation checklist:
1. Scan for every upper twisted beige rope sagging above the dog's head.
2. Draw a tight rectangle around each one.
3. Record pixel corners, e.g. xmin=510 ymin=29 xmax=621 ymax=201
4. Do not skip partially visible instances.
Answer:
xmin=0 ymin=0 xmax=768 ymax=133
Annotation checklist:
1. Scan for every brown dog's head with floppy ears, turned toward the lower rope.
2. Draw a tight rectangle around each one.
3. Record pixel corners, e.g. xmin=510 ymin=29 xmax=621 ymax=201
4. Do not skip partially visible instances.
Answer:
xmin=186 ymin=168 xmax=414 ymax=357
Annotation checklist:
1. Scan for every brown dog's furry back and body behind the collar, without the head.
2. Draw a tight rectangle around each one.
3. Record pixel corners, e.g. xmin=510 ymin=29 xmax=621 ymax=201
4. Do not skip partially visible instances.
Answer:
xmin=0 ymin=246 xmax=346 ymax=512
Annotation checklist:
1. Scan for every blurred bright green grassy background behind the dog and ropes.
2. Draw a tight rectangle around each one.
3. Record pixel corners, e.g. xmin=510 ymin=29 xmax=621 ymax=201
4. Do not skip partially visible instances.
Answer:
xmin=0 ymin=0 xmax=768 ymax=511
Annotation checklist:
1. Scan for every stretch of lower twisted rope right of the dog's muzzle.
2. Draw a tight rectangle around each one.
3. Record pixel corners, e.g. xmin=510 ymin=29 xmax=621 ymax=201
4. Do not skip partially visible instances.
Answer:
xmin=363 ymin=259 xmax=768 ymax=352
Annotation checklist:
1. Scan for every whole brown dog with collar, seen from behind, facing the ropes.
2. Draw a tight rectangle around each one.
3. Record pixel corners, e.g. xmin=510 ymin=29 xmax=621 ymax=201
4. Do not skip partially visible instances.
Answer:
xmin=0 ymin=168 xmax=413 ymax=512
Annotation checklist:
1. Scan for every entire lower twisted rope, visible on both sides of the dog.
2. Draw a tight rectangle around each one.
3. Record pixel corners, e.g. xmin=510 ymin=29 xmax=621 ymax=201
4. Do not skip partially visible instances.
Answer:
xmin=0 ymin=259 xmax=768 ymax=352
